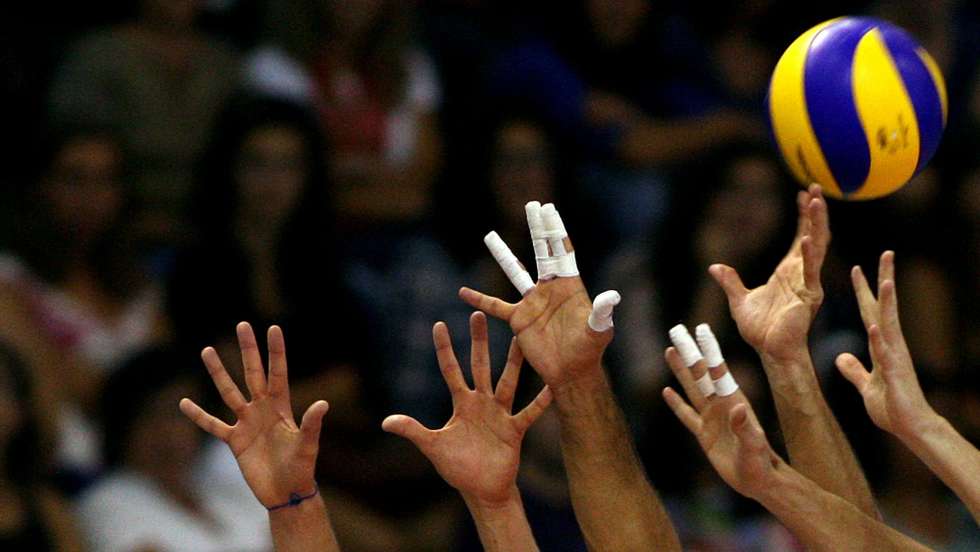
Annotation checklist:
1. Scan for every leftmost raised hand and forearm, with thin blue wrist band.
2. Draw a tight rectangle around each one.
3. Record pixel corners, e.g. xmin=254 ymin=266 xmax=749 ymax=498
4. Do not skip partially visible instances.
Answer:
xmin=180 ymin=322 xmax=340 ymax=552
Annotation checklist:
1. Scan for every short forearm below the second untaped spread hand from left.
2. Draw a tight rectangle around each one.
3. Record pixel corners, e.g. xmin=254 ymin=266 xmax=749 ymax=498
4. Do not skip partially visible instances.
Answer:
xmin=463 ymin=487 xmax=538 ymax=552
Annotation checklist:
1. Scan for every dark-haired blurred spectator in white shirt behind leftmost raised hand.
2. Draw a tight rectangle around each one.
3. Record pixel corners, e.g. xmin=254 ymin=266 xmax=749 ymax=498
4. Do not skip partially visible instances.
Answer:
xmin=77 ymin=349 xmax=271 ymax=552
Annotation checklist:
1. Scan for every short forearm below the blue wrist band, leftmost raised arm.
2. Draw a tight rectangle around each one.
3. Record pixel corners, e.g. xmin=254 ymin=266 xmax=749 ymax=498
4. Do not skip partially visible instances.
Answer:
xmin=269 ymin=494 xmax=340 ymax=552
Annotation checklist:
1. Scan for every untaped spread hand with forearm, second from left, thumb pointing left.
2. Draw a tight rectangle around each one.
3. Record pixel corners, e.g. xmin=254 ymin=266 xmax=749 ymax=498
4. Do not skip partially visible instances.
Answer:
xmin=382 ymin=312 xmax=551 ymax=552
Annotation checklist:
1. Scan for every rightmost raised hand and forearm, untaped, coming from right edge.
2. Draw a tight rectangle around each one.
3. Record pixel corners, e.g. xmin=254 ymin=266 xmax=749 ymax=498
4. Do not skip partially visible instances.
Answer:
xmin=837 ymin=251 xmax=980 ymax=522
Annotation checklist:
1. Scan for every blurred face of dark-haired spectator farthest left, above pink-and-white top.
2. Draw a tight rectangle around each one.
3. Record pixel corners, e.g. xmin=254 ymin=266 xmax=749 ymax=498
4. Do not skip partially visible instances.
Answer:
xmin=42 ymin=137 xmax=122 ymax=241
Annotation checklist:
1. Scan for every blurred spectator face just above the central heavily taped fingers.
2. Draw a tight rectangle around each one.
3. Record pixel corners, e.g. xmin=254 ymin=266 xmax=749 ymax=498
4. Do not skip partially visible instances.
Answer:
xmin=492 ymin=122 xmax=555 ymax=233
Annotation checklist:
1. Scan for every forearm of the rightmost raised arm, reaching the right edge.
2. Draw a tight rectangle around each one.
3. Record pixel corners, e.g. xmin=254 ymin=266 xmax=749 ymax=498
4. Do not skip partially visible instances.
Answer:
xmin=900 ymin=414 xmax=980 ymax=523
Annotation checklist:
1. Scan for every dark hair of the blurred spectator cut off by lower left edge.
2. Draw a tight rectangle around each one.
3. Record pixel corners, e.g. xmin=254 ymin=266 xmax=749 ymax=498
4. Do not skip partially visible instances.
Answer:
xmin=0 ymin=342 xmax=50 ymax=489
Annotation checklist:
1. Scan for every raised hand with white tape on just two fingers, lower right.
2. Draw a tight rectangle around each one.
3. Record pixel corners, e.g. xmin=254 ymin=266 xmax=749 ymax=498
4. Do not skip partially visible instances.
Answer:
xmin=663 ymin=324 xmax=783 ymax=498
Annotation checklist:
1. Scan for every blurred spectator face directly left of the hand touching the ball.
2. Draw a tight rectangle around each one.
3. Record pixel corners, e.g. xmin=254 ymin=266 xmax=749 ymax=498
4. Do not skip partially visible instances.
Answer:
xmin=699 ymin=157 xmax=783 ymax=263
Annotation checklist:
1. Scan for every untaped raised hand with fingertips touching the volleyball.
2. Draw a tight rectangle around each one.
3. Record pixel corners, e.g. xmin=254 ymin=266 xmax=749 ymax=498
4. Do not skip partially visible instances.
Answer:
xmin=709 ymin=184 xmax=830 ymax=359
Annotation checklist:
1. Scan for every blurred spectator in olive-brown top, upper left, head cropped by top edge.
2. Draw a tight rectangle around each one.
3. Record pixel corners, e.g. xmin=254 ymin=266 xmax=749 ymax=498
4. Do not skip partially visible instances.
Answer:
xmin=50 ymin=0 xmax=238 ymax=244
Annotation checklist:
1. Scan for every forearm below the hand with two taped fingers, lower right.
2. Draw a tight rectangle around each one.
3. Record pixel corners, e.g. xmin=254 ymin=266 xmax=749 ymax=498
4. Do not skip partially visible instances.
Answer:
xmin=756 ymin=464 xmax=928 ymax=552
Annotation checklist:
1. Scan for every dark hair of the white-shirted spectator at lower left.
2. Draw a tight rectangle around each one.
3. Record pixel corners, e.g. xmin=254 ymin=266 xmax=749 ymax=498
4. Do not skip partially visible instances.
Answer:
xmin=100 ymin=347 xmax=197 ymax=467
